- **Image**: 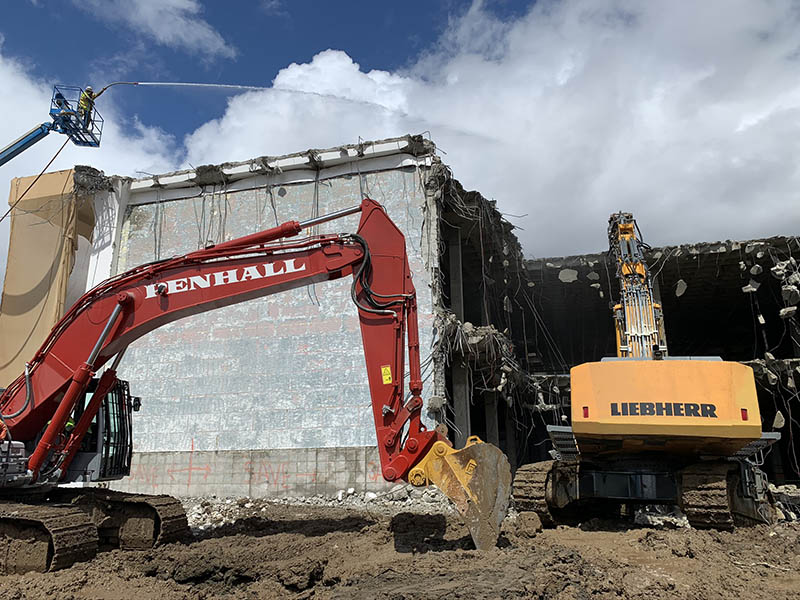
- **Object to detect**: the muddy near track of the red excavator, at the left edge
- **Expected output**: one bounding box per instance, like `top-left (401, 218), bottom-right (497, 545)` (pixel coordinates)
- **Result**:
top-left (0, 502), bottom-right (98, 574)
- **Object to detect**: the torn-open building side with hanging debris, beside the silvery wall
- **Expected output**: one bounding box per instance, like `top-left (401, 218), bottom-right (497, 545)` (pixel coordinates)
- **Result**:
top-left (428, 164), bottom-right (534, 465)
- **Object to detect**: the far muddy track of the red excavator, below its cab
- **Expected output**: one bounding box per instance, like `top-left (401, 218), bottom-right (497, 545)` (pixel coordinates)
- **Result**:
top-left (54, 488), bottom-right (191, 549)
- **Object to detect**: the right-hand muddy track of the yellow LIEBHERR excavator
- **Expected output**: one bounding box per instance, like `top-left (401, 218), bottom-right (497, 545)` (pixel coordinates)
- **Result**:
top-left (680, 462), bottom-right (734, 530)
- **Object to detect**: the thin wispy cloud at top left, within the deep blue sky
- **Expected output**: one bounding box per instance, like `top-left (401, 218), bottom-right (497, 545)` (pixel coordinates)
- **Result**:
top-left (73, 0), bottom-right (236, 58)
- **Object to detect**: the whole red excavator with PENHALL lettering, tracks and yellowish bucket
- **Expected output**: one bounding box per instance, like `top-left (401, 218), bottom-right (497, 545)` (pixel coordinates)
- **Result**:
top-left (0, 199), bottom-right (511, 573)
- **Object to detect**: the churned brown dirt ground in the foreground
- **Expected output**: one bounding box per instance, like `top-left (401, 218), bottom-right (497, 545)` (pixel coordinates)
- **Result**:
top-left (0, 503), bottom-right (800, 600)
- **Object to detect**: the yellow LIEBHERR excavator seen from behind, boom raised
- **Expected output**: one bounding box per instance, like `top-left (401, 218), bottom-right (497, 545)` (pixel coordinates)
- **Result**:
top-left (513, 212), bottom-right (780, 529)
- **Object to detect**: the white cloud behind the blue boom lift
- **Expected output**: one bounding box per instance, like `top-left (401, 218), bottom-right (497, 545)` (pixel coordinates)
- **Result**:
top-left (0, 46), bottom-right (177, 281)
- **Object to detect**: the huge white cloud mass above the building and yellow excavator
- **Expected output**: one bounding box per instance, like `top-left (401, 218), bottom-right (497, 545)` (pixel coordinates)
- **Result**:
top-left (181, 0), bottom-right (800, 256)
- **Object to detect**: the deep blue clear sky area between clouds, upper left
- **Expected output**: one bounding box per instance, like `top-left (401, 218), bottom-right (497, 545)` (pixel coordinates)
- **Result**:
top-left (0, 0), bottom-right (530, 138)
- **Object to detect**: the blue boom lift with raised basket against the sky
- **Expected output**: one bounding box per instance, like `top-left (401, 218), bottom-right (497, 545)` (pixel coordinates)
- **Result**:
top-left (0, 85), bottom-right (103, 166)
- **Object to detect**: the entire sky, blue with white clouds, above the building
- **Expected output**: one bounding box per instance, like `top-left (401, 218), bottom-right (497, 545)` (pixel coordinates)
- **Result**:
top-left (0, 0), bottom-right (800, 290)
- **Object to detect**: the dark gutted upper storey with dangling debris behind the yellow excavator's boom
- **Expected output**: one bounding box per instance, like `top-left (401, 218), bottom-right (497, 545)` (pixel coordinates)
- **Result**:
top-left (526, 237), bottom-right (800, 372)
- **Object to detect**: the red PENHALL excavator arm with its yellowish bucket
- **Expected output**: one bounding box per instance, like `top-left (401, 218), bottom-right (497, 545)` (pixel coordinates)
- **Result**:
top-left (0, 199), bottom-right (511, 548)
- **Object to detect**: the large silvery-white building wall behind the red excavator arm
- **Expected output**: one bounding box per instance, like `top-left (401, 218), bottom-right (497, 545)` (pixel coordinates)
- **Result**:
top-left (108, 157), bottom-right (436, 462)
